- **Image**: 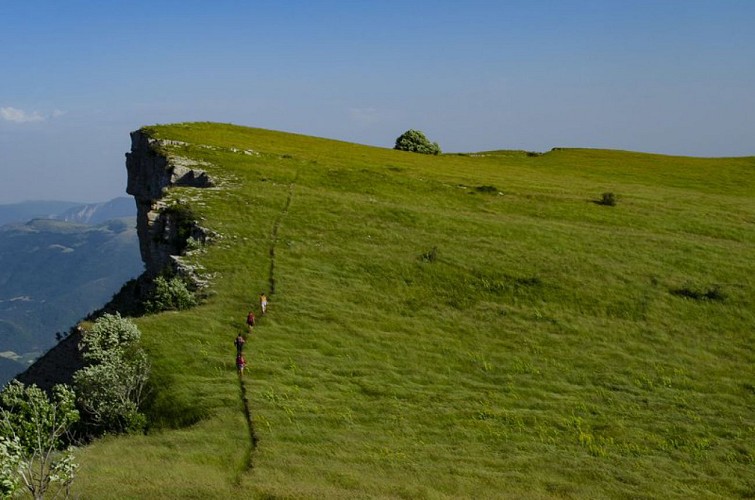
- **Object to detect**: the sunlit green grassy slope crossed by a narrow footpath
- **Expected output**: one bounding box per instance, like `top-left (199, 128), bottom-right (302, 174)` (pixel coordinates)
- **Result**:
top-left (77, 124), bottom-right (755, 498)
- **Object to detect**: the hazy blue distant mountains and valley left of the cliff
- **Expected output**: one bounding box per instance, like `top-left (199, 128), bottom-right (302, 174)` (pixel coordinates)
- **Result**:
top-left (0, 197), bottom-right (143, 384)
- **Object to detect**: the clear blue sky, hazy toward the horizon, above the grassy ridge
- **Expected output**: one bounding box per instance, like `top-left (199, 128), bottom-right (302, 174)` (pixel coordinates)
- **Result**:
top-left (0, 0), bottom-right (755, 204)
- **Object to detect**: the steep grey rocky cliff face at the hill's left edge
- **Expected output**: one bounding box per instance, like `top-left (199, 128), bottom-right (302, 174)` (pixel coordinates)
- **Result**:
top-left (126, 130), bottom-right (213, 283)
